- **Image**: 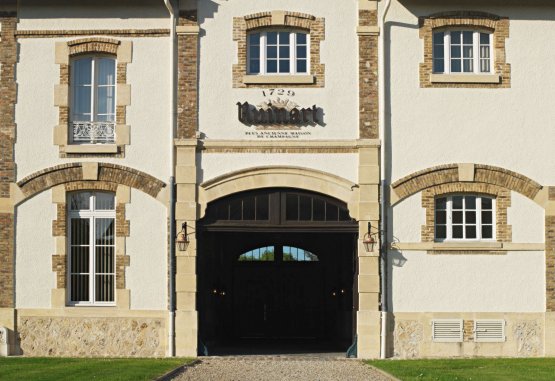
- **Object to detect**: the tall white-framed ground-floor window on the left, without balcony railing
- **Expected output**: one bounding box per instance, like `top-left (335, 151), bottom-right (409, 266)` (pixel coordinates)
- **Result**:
top-left (68, 192), bottom-right (116, 305)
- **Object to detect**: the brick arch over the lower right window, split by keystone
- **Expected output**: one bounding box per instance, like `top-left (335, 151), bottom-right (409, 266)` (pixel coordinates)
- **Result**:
top-left (391, 164), bottom-right (542, 201)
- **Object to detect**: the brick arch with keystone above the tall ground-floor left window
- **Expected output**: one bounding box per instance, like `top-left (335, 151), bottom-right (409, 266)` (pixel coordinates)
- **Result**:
top-left (17, 163), bottom-right (166, 201)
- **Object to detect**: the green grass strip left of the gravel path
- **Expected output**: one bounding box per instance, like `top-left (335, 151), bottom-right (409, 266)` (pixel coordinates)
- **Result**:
top-left (0, 357), bottom-right (194, 381)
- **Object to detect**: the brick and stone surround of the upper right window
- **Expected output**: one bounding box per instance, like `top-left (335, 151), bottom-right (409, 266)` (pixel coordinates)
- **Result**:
top-left (419, 11), bottom-right (511, 88)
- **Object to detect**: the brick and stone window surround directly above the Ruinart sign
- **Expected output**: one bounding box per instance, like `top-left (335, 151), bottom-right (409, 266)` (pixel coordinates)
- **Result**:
top-left (233, 11), bottom-right (325, 88)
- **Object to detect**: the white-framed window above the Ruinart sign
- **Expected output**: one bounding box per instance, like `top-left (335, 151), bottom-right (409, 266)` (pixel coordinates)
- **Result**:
top-left (247, 30), bottom-right (310, 75)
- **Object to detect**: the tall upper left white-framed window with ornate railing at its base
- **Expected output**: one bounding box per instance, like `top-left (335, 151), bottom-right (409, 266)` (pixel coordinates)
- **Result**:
top-left (70, 56), bottom-right (116, 144)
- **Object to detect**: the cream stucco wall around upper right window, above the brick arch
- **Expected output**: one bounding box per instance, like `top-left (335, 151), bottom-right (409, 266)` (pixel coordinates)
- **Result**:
top-left (386, 0), bottom-right (555, 184)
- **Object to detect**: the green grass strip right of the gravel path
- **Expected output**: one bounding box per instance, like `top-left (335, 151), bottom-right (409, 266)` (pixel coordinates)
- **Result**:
top-left (366, 358), bottom-right (555, 381)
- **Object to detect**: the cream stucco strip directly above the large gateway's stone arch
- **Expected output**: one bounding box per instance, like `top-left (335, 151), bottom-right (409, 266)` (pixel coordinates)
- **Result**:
top-left (200, 153), bottom-right (358, 183)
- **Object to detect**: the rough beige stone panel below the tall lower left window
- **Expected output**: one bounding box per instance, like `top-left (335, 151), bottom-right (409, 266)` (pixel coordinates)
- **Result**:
top-left (19, 317), bottom-right (165, 357)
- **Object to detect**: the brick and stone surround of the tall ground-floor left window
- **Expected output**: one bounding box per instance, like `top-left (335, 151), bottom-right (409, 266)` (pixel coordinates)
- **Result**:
top-left (51, 181), bottom-right (131, 310)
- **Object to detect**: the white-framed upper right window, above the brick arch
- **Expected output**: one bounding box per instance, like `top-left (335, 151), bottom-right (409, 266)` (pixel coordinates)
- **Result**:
top-left (433, 30), bottom-right (493, 74)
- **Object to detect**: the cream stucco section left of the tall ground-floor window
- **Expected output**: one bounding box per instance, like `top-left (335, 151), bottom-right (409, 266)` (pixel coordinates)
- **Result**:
top-left (15, 191), bottom-right (56, 308)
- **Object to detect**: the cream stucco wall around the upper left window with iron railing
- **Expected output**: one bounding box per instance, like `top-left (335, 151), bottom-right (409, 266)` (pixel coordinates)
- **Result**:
top-left (15, 36), bottom-right (171, 181)
